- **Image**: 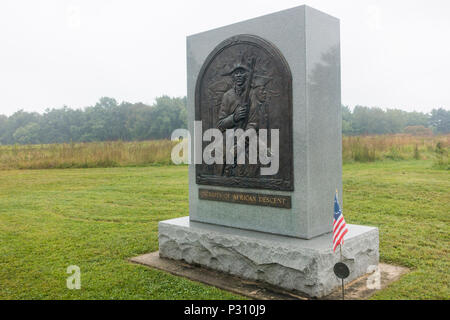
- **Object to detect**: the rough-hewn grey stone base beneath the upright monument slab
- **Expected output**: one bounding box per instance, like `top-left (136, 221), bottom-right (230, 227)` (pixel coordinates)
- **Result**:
top-left (159, 217), bottom-right (379, 298)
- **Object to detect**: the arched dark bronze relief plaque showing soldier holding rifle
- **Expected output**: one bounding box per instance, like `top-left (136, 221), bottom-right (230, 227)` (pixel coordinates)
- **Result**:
top-left (195, 35), bottom-right (294, 191)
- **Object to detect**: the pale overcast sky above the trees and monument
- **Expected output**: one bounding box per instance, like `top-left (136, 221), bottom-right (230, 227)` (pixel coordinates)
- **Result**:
top-left (0, 0), bottom-right (450, 115)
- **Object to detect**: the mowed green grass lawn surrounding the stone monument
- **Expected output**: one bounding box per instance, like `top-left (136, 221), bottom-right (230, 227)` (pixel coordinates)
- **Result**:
top-left (0, 161), bottom-right (450, 299)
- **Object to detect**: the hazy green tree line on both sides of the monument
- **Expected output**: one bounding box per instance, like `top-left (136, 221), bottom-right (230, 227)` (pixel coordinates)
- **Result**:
top-left (0, 96), bottom-right (450, 145)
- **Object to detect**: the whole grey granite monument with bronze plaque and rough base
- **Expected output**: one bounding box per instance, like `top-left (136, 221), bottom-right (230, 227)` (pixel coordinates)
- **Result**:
top-left (159, 6), bottom-right (379, 297)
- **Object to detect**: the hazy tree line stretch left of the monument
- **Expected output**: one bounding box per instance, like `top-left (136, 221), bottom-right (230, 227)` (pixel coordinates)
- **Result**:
top-left (0, 96), bottom-right (187, 144)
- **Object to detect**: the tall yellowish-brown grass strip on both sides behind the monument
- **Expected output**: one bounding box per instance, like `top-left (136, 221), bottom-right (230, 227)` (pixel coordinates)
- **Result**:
top-left (0, 134), bottom-right (450, 170)
